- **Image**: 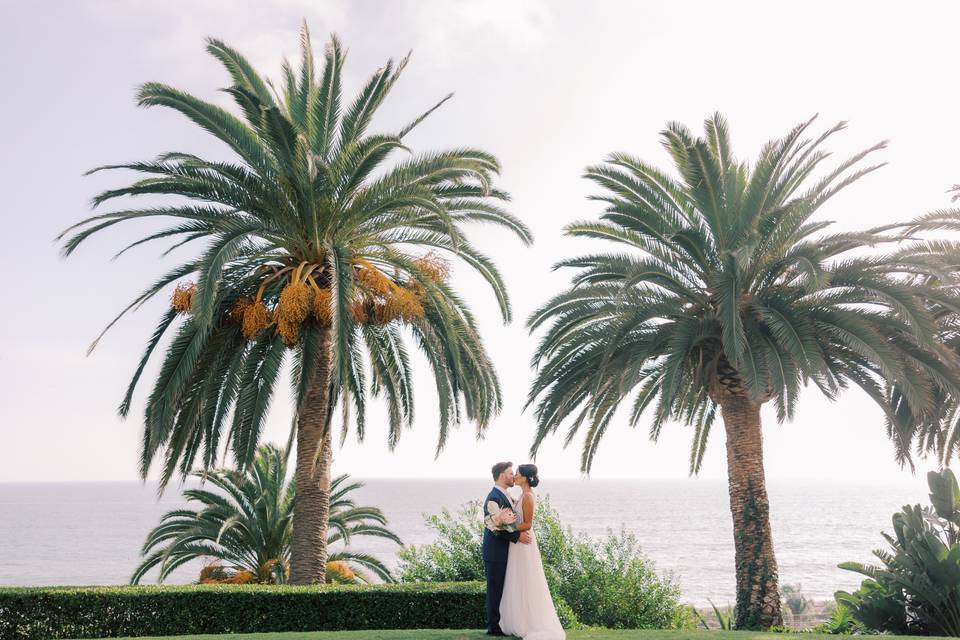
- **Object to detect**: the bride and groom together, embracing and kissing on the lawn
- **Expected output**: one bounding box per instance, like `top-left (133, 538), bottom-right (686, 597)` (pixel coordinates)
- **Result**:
top-left (483, 462), bottom-right (566, 640)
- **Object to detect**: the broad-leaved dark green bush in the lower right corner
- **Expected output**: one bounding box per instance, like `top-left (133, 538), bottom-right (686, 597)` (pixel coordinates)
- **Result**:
top-left (836, 469), bottom-right (960, 636)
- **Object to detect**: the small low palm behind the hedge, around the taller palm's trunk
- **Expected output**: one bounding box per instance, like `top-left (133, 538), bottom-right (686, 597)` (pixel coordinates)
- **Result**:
top-left (130, 445), bottom-right (402, 584)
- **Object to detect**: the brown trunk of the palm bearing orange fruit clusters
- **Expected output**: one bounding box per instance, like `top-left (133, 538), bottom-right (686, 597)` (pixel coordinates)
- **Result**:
top-left (290, 327), bottom-right (333, 584)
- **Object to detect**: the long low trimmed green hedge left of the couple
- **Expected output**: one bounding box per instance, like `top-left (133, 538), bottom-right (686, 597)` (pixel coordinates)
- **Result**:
top-left (0, 582), bottom-right (485, 640)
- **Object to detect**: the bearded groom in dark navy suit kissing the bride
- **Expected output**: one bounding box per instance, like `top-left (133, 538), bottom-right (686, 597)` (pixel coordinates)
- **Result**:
top-left (483, 462), bottom-right (530, 636)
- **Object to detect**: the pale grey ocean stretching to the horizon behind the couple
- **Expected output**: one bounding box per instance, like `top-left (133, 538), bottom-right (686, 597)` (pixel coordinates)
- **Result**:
top-left (0, 478), bottom-right (928, 606)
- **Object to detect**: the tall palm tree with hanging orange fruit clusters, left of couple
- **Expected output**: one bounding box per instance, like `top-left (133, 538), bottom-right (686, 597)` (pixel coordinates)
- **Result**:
top-left (61, 27), bottom-right (532, 584)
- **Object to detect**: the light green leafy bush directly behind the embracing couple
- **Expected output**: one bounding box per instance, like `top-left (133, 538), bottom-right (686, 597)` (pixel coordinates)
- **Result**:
top-left (397, 500), bottom-right (692, 629)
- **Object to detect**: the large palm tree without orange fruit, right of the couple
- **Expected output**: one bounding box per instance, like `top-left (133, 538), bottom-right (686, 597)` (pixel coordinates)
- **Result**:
top-left (528, 115), bottom-right (960, 628)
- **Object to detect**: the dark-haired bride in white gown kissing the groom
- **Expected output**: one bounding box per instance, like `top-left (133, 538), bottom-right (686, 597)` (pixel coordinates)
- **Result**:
top-left (500, 464), bottom-right (566, 640)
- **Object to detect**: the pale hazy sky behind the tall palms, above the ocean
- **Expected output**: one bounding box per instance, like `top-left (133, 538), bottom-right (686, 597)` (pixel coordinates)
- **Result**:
top-left (0, 0), bottom-right (960, 483)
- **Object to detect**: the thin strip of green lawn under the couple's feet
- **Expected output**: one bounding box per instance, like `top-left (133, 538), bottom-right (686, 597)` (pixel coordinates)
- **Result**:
top-left (103, 629), bottom-right (928, 640)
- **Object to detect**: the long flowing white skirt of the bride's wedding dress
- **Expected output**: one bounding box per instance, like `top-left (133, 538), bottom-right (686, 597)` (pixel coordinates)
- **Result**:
top-left (500, 498), bottom-right (566, 640)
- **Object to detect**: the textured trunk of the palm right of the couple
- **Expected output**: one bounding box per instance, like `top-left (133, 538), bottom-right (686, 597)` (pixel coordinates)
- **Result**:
top-left (720, 393), bottom-right (783, 629)
